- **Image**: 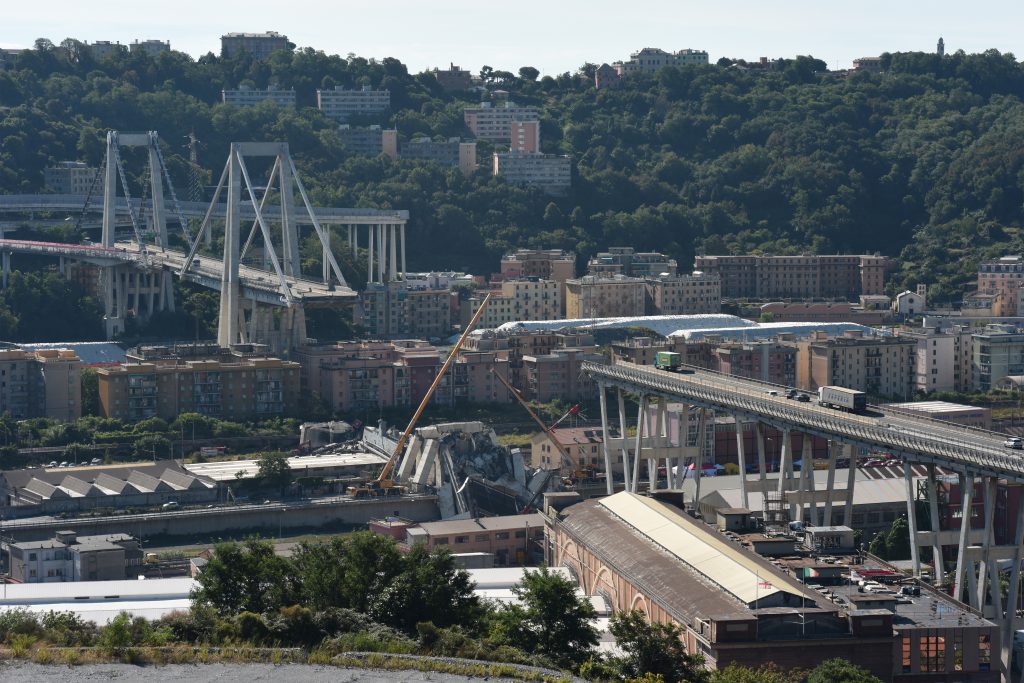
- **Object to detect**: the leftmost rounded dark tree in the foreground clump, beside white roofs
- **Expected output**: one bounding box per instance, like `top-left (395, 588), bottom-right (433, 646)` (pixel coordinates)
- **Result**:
top-left (191, 538), bottom-right (295, 615)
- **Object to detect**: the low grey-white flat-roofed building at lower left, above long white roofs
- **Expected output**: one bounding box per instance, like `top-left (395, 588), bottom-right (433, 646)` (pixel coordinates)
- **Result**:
top-left (7, 531), bottom-right (142, 584)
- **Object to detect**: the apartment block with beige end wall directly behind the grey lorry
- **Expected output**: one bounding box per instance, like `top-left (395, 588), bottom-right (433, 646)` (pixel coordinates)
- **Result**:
top-left (797, 331), bottom-right (918, 399)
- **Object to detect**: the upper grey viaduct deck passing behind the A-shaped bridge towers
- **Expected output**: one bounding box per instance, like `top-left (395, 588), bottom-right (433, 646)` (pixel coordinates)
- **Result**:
top-left (0, 194), bottom-right (409, 225)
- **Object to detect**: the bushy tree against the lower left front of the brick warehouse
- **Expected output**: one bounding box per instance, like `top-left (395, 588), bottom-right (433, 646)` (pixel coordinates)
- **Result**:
top-left (609, 609), bottom-right (708, 683)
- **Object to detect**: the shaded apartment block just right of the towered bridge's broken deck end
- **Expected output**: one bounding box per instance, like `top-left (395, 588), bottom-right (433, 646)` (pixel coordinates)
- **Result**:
top-left (355, 282), bottom-right (453, 339)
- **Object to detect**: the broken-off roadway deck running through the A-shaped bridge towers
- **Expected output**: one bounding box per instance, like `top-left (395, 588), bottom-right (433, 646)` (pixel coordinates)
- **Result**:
top-left (0, 240), bottom-right (355, 307)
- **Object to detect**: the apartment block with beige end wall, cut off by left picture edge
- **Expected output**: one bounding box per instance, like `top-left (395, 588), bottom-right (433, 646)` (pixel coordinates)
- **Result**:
top-left (0, 344), bottom-right (82, 422)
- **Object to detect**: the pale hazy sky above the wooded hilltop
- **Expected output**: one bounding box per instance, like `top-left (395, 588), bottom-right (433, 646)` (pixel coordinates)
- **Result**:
top-left (0, 0), bottom-right (1024, 74)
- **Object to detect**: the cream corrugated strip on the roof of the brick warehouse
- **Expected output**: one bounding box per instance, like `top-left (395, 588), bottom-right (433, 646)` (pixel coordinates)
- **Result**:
top-left (600, 492), bottom-right (804, 604)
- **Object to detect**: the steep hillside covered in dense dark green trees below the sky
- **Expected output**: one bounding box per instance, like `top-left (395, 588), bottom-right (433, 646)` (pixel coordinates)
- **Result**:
top-left (0, 40), bottom-right (1024, 301)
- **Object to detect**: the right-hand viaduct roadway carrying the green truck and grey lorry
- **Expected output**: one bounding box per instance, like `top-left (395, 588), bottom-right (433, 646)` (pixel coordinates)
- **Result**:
top-left (582, 361), bottom-right (1024, 483)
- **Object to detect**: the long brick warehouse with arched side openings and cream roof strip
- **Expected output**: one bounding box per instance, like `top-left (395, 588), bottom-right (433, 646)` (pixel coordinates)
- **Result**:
top-left (546, 493), bottom-right (999, 683)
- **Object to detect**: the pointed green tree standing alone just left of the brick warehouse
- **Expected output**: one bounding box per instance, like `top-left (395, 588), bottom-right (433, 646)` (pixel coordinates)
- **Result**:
top-left (494, 564), bottom-right (598, 667)
